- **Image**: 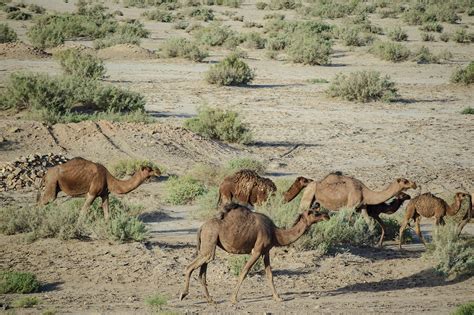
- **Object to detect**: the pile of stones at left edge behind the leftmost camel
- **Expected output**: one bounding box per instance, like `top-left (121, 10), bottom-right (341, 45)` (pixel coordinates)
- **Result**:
top-left (0, 153), bottom-right (68, 191)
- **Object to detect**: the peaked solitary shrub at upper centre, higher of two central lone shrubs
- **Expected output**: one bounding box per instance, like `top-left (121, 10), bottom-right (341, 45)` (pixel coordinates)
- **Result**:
top-left (206, 54), bottom-right (255, 85)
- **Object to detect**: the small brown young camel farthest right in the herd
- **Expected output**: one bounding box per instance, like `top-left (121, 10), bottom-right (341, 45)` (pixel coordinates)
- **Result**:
top-left (398, 192), bottom-right (471, 249)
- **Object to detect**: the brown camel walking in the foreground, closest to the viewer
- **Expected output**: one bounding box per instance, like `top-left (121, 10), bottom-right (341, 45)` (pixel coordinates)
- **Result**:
top-left (180, 203), bottom-right (329, 303)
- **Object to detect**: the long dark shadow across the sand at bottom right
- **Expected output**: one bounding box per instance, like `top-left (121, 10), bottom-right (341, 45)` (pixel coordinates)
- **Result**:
top-left (326, 268), bottom-right (470, 296)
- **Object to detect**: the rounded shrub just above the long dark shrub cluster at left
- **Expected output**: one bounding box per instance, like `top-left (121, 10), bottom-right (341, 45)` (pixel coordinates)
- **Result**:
top-left (55, 48), bottom-right (105, 79)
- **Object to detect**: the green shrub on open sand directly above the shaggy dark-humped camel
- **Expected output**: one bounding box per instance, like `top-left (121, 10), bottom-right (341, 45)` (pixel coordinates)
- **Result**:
top-left (184, 106), bottom-right (251, 144)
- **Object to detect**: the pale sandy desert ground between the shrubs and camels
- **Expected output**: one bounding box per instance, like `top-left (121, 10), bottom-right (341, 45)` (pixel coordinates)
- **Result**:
top-left (0, 0), bottom-right (474, 314)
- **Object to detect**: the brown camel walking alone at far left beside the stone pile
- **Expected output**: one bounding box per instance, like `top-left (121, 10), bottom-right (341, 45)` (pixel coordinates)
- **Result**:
top-left (37, 157), bottom-right (161, 220)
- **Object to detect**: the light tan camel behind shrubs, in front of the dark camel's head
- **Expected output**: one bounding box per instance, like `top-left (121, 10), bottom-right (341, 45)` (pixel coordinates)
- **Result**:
top-left (300, 173), bottom-right (416, 211)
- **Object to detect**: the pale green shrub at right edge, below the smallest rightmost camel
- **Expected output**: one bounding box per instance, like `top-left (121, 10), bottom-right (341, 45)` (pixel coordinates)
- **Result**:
top-left (425, 222), bottom-right (474, 277)
